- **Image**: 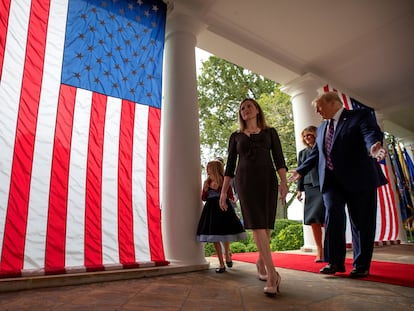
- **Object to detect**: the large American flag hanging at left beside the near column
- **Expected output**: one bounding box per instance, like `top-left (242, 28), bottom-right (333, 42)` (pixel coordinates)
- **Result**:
top-left (0, 0), bottom-right (168, 277)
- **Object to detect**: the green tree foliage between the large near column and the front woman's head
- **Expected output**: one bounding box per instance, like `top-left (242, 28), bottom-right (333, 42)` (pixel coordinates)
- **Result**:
top-left (198, 56), bottom-right (276, 160)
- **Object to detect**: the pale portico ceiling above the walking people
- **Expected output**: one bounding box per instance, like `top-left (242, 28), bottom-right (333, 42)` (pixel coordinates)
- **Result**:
top-left (170, 0), bottom-right (414, 144)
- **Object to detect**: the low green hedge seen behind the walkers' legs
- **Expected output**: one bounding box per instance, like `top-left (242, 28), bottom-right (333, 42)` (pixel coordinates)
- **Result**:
top-left (204, 219), bottom-right (303, 257)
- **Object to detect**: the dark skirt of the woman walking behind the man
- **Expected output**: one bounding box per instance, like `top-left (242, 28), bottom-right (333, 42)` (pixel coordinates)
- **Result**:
top-left (303, 184), bottom-right (325, 225)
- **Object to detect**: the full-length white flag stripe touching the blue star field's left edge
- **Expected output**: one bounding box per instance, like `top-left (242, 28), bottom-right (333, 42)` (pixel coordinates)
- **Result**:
top-left (23, 1), bottom-right (67, 269)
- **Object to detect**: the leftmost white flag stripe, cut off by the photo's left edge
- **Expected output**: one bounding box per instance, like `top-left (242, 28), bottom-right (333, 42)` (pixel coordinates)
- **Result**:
top-left (0, 0), bottom-right (30, 260)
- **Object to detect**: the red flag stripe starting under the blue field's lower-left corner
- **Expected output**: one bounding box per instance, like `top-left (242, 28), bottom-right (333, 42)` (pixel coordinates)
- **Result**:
top-left (45, 84), bottom-right (76, 271)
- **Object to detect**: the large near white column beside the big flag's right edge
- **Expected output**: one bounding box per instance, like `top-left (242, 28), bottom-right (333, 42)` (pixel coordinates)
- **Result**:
top-left (161, 14), bottom-right (207, 265)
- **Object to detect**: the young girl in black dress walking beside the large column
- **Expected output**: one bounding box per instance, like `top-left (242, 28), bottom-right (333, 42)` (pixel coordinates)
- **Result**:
top-left (197, 160), bottom-right (247, 273)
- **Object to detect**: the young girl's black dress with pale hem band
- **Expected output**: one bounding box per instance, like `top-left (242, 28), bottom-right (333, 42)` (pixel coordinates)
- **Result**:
top-left (197, 187), bottom-right (247, 242)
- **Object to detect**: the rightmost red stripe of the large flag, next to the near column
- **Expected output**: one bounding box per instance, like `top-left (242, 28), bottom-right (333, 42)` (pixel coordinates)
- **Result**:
top-left (146, 107), bottom-right (164, 261)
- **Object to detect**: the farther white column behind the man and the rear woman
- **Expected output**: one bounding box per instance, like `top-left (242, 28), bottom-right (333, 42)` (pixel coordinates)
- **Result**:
top-left (282, 73), bottom-right (326, 252)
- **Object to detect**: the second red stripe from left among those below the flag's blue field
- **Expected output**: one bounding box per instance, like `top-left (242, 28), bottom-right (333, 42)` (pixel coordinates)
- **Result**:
top-left (85, 93), bottom-right (106, 269)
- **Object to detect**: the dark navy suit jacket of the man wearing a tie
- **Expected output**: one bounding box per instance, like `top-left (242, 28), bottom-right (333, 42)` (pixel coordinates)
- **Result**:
top-left (296, 109), bottom-right (387, 192)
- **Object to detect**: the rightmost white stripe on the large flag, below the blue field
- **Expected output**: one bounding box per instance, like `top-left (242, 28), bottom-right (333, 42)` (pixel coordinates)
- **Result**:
top-left (132, 104), bottom-right (151, 262)
